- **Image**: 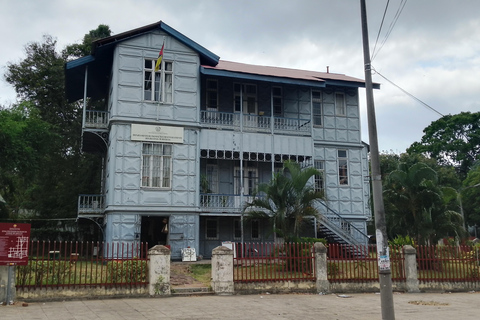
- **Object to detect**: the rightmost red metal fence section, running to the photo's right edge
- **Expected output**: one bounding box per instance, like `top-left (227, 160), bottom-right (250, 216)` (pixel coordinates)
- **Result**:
top-left (417, 246), bottom-right (480, 283)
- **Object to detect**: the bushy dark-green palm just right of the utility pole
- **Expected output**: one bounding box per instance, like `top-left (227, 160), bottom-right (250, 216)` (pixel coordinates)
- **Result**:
top-left (384, 162), bottom-right (464, 244)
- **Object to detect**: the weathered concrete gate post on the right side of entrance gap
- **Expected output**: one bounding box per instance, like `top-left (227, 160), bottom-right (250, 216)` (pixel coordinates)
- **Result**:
top-left (212, 246), bottom-right (234, 295)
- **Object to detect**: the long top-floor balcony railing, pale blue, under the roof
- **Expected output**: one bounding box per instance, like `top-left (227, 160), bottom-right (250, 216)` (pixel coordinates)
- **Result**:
top-left (201, 110), bottom-right (310, 135)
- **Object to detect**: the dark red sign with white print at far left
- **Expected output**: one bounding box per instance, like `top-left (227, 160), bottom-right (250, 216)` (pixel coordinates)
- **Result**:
top-left (0, 223), bottom-right (30, 265)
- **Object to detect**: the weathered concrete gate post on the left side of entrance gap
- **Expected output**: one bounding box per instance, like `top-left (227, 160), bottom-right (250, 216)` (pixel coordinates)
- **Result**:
top-left (148, 245), bottom-right (171, 296)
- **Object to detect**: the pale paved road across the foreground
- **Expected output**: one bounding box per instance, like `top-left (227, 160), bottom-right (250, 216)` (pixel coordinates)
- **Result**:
top-left (0, 292), bottom-right (480, 320)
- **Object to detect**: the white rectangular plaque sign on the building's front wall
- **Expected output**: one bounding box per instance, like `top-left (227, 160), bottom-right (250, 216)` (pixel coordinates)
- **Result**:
top-left (130, 124), bottom-right (183, 143)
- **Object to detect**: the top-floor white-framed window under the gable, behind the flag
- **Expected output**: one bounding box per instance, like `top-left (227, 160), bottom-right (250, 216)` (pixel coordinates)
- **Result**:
top-left (143, 59), bottom-right (173, 103)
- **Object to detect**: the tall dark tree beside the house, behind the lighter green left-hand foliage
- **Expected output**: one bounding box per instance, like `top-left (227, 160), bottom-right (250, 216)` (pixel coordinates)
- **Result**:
top-left (0, 25), bottom-right (110, 224)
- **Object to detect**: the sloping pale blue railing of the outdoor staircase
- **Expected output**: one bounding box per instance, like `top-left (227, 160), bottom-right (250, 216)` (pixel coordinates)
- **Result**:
top-left (317, 201), bottom-right (368, 245)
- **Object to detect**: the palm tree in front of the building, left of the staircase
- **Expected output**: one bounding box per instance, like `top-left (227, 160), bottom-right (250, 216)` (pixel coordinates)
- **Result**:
top-left (245, 161), bottom-right (324, 239)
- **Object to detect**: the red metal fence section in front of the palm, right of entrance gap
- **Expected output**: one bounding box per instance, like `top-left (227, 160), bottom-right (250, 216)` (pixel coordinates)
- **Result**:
top-left (233, 243), bottom-right (316, 282)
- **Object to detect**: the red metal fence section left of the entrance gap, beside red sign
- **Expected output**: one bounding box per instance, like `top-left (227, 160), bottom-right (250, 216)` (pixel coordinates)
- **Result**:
top-left (16, 241), bottom-right (148, 289)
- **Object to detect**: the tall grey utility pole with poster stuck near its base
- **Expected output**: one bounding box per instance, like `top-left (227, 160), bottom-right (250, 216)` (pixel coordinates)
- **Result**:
top-left (360, 0), bottom-right (395, 320)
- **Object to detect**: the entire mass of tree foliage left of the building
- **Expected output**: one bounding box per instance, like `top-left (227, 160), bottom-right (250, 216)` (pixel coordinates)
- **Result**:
top-left (0, 25), bottom-right (111, 222)
